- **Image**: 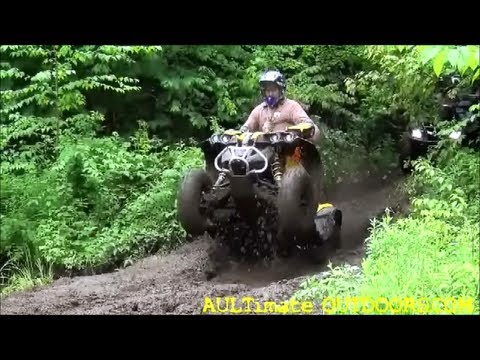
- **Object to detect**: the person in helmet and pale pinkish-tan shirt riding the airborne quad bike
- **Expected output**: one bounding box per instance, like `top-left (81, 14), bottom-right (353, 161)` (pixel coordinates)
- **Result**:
top-left (240, 70), bottom-right (320, 144)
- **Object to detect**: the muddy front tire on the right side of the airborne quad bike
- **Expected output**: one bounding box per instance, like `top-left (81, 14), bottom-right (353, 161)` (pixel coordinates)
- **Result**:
top-left (278, 166), bottom-right (319, 250)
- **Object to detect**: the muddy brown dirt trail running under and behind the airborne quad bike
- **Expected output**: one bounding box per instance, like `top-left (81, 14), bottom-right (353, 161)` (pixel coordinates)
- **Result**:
top-left (0, 167), bottom-right (402, 314)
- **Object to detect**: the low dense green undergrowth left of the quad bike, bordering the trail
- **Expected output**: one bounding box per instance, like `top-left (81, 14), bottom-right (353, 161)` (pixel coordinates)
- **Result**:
top-left (0, 125), bottom-right (202, 290)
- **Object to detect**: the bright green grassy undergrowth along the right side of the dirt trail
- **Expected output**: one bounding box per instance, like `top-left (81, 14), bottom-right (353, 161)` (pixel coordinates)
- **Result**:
top-left (294, 147), bottom-right (480, 314)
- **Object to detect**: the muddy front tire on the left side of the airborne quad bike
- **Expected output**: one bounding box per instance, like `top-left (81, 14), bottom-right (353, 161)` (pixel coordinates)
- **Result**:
top-left (177, 169), bottom-right (213, 236)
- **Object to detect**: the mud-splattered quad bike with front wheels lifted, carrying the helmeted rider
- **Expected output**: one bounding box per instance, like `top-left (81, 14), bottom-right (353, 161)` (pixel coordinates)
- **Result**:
top-left (177, 124), bottom-right (341, 268)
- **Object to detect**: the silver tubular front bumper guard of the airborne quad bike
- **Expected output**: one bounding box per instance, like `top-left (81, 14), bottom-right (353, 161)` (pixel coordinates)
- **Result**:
top-left (214, 146), bottom-right (268, 176)
